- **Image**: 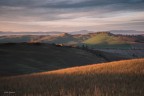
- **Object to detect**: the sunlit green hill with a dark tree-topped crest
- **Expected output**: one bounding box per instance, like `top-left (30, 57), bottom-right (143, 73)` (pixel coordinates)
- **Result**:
top-left (84, 32), bottom-right (135, 45)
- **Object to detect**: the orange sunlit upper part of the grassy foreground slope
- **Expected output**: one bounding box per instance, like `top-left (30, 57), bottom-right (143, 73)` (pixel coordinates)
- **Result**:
top-left (46, 59), bottom-right (144, 75)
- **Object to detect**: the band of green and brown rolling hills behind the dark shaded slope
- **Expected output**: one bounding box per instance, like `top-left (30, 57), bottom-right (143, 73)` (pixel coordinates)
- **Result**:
top-left (0, 32), bottom-right (144, 49)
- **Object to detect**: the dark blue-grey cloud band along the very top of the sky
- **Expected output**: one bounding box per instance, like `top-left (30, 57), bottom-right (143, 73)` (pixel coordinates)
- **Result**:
top-left (0, 0), bottom-right (144, 9)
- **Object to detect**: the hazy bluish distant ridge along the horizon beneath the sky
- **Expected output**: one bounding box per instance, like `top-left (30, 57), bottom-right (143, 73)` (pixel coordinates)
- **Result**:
top-left (0, 30), bottom-right (144, 36)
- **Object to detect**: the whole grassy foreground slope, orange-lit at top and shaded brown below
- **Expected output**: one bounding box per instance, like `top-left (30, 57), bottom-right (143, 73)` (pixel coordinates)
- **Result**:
top-left (0, 59), bottom-right (144, 96)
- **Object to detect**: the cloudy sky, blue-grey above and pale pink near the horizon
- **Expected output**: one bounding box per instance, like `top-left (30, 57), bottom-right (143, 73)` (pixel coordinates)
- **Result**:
top-left (0, 0), bottom-right (144, 32)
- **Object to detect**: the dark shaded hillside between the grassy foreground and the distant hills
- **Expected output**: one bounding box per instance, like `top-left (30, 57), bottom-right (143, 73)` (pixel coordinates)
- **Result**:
top-left (0, 43), bottom-right (127, 76)
